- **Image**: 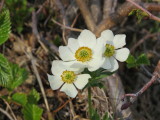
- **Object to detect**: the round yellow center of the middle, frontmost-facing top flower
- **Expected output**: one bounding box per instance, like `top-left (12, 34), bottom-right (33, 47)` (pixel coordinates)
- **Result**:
top-left (75, 47), bottom-right (92, 62)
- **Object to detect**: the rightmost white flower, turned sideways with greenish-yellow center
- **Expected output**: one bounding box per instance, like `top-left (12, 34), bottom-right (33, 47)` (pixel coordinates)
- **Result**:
top-left (97, 30), bottom-right (130, 72)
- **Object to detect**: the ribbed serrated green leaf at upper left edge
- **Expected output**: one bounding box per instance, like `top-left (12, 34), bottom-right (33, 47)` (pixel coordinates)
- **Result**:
top-left (0, 10), bottom-right (11, 45)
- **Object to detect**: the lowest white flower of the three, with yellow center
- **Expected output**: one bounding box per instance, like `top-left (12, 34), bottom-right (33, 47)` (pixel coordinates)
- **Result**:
top-left (48, 60), bottom-right (91, 98)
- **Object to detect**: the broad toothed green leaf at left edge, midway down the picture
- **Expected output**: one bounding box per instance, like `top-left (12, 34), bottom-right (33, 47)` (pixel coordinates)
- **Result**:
top-left (0, 54), bottom-right (28, 91)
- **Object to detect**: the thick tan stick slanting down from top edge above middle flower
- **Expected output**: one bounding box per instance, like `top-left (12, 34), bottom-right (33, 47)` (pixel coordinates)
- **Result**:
top-left (76, 0), bottom-right (96, 31)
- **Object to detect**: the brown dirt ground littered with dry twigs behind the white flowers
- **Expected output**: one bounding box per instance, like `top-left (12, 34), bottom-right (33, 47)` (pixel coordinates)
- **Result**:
top-left (0, 0), bottom-right (160, 120)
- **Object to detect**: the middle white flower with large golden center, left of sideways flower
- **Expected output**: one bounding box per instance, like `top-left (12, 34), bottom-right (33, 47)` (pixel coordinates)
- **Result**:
top-left (59, 30), bottom-right (102, 71)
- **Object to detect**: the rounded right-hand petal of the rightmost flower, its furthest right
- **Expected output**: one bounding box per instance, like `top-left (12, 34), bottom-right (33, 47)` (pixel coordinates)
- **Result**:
top-left (114, 48), bottom-right (130, 62)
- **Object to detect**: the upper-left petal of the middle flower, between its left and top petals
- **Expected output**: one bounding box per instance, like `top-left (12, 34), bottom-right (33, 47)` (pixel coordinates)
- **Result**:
top-left (68, 38), bottom-right (79, 53)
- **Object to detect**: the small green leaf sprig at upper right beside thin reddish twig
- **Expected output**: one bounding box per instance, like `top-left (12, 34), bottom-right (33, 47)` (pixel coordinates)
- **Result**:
top-left (129, 9), bottom-right (148, 23)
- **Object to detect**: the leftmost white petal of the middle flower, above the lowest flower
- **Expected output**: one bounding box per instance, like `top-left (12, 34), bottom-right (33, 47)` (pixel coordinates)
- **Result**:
top-left (59, 46), bottom-right (75, 61)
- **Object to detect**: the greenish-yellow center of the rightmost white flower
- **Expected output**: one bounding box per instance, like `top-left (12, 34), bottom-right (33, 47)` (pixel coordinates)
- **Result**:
top-left (104, 44), bottom-right (115, 57)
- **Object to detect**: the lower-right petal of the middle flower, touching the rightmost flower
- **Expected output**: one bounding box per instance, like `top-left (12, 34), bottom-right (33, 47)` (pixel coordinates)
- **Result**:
top-left (88, 56), bottom-right (105, 71)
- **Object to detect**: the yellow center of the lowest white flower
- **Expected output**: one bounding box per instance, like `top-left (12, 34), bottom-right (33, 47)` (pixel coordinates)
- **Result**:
top-left (61, 70), bottom-right (76, 84)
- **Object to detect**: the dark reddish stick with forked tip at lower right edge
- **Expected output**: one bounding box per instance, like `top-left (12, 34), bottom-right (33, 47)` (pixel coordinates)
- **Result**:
top-left (121, 60), bottom-right (160, 110)
